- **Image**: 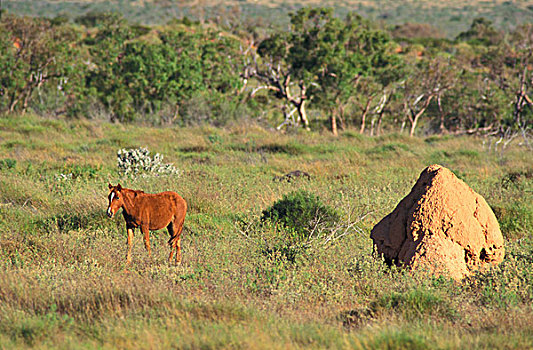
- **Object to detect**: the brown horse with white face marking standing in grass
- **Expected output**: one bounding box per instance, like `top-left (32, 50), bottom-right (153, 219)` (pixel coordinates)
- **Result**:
top-left (107, 184), bottom-right (187, 264)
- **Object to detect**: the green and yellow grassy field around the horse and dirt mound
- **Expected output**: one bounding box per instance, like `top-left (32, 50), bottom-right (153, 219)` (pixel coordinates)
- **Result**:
top-left (0, 116), bottom-right (533, 349)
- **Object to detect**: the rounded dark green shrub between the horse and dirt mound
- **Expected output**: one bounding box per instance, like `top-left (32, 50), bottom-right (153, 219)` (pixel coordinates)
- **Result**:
top-left (261, 190), bottom-right (339, 242)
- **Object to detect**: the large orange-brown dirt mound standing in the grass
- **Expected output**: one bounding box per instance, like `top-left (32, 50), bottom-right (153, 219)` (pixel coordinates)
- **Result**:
top-left (370, 165), bottom-right (504, 280)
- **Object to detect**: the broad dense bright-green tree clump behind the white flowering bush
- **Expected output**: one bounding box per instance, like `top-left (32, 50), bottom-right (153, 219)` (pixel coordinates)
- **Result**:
top-left (82, 17), bottom-right (241, 122)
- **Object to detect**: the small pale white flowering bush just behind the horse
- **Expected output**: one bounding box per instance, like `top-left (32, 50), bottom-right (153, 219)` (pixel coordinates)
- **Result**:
top-left (117, 147), bottom-right (180, 176)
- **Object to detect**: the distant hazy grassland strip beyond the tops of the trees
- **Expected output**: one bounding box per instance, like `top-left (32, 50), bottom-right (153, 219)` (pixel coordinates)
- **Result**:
top-left (3, 0), bottom-right (533, 38)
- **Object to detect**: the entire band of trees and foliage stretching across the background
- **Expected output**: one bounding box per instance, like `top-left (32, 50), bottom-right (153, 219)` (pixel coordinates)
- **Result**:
top-left (0, 5), bottom-right (533, 139)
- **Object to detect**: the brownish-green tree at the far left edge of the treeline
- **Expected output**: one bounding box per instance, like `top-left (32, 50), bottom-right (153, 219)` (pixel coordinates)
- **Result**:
top-left (0, 16), bottom-right (79, 113)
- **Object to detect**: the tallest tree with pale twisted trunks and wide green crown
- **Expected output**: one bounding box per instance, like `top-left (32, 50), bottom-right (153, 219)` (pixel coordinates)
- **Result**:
top-left (252, 8), bottom-right (399, 134)
